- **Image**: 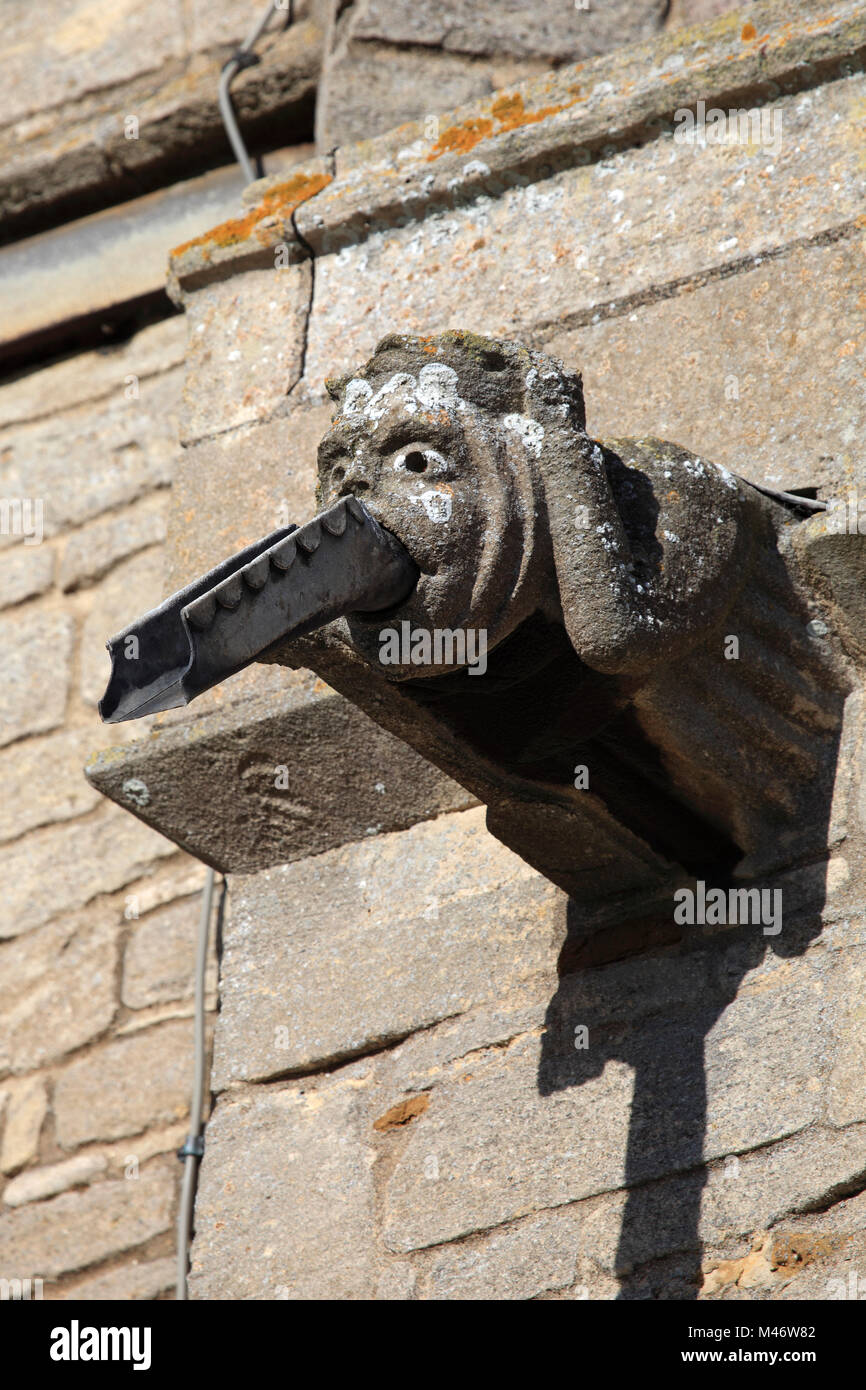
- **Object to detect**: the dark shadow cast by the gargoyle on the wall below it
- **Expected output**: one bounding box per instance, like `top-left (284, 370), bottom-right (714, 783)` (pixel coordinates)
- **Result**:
top-left (538, 850), bottom-right (841, 1300)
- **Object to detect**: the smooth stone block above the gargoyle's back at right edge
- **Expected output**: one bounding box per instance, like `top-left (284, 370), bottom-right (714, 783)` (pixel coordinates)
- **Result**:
top-left (545, 236), bottom-right (866, 499)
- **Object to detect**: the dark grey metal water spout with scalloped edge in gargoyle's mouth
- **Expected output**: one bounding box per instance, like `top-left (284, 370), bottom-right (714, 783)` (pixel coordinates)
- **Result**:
top-left (99, 496), bottom-right (418, 724)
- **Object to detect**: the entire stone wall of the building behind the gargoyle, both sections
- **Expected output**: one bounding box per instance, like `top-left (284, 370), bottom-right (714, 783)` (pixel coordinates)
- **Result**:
top-left (0, 0), bottom-right (866, 1298)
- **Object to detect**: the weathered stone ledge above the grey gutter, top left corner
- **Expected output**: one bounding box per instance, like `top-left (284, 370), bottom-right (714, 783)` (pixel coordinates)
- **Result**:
top-left (0, 0), bottom-right (322, 236)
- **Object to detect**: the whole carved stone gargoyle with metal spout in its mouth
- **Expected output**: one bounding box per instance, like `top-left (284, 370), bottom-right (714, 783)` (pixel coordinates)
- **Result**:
top-left (100, 332), bottom-right (856, 904)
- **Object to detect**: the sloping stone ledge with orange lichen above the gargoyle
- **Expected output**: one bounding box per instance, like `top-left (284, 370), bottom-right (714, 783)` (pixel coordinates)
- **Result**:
top-left (171, 0), bottom-right (866, 297)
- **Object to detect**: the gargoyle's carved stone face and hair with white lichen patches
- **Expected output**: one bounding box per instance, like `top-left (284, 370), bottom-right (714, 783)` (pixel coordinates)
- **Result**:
top-left (312, 332), bottom-right (584, 678)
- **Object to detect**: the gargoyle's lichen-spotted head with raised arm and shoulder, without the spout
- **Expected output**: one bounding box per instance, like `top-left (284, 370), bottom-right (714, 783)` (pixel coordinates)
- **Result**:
top-left (318, 332), bottom-right (749, 678)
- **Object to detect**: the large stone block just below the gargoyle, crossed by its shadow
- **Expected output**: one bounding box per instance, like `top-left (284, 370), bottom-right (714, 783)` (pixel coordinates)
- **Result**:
top-left (386, 941), bottom-right (859, 1251)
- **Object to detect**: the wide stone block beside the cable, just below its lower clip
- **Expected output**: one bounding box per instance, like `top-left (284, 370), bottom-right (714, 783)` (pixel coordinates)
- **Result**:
top-left (0, 1163), bottom-right (177, 1279)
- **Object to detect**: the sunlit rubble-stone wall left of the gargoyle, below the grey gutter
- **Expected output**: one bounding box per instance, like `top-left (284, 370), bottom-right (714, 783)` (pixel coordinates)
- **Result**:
top-left (0, 318), bottom-right (215, 1298)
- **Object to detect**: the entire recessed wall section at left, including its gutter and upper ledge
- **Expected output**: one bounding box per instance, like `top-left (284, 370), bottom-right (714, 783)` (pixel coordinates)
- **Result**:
top-left (0, 0), bottom-right (322, 1300)
